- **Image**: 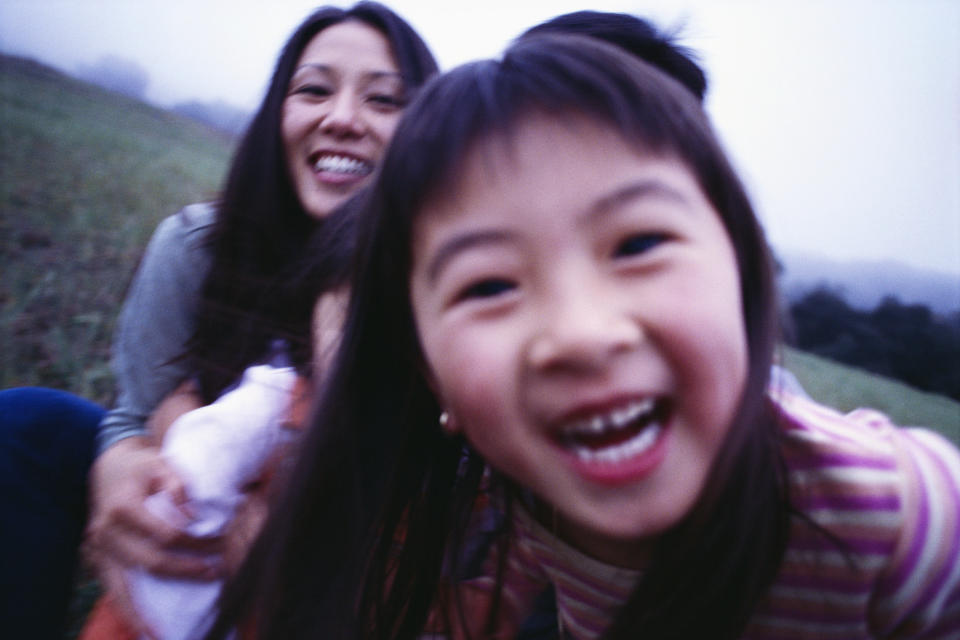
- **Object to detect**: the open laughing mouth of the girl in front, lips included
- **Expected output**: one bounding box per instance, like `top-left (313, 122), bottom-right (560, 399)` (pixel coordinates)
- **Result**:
top-left (558, 398), bottom-right (670, 484)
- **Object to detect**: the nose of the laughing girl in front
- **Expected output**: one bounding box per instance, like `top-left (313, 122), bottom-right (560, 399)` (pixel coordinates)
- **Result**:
top-left (528, 291), bottom-right (644, 371)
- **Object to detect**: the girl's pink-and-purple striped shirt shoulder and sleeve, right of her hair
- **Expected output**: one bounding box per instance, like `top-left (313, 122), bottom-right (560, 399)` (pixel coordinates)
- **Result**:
top-left (771, 393), bottom-right (960, 637)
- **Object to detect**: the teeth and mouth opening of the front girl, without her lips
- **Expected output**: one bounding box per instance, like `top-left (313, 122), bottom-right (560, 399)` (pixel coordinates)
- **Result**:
top-left (562, 398), bottom-right (661, 463)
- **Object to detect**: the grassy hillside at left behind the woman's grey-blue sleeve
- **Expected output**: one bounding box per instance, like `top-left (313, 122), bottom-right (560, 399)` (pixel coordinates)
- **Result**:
top-left (0, 56), bottom-right (233, 403)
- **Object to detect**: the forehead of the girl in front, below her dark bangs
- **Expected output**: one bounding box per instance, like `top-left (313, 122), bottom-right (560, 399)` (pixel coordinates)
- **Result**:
top-left (414, 114), bottom-right (710, 245)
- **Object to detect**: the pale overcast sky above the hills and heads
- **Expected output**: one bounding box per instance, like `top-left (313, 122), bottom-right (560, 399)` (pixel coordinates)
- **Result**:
top-left (0, 0), bottom-right (960, 277)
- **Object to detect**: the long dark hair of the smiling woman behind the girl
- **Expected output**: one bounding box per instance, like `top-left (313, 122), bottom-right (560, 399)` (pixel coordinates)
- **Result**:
top-left (188, 2), bottom-right (437, 402)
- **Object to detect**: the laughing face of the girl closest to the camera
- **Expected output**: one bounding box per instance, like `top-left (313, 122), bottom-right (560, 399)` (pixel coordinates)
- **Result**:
top-left (410, 116), bottom-right (748, 566)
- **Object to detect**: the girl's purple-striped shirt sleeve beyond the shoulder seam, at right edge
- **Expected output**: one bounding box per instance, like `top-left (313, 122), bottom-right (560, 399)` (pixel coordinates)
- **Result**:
top-left (872, 420), bottom-right (960, 638)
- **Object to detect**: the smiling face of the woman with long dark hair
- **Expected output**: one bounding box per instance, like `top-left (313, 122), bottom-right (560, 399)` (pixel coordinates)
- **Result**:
top-left (280, 21), bottom-right (406, 218)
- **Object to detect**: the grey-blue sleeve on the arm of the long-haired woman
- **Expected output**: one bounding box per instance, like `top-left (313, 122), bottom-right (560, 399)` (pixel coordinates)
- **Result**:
top-left (97, 204), bottom-right (213, 453)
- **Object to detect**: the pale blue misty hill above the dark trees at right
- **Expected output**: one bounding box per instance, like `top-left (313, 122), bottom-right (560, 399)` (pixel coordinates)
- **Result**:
top-left (777, 252), bottom-right (960, 315)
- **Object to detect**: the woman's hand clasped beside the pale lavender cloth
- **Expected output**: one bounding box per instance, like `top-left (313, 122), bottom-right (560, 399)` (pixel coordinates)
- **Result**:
top-left (85, 437), bottom-right (222, 634)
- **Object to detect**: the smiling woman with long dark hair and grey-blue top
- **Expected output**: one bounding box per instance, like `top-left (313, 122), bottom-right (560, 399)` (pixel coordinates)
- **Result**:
top-left (3, 2), bottom-right (437, 637)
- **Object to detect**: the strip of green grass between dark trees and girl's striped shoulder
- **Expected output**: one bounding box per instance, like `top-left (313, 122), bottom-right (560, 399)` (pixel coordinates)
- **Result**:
top-left (782, 348), bottom-right (960, 445)
